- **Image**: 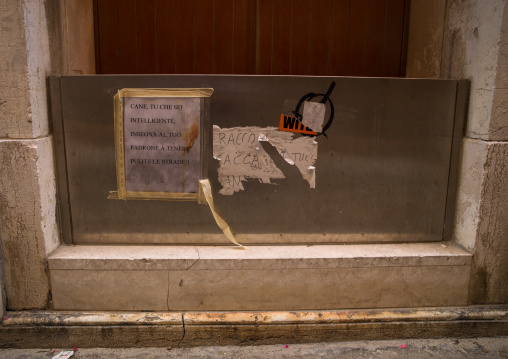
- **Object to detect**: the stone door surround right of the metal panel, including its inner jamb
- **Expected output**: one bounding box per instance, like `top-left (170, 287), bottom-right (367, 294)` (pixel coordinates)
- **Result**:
top-left (408, 0), bottom-right (508, 304)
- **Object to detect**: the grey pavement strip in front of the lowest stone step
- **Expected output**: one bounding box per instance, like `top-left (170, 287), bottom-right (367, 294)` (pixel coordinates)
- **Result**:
top-left (0, 337), bottom-right (508, 359)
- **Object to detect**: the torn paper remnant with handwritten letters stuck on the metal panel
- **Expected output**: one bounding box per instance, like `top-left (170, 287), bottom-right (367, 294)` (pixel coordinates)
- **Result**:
top-left (213, 126), bottom-right (317, 195)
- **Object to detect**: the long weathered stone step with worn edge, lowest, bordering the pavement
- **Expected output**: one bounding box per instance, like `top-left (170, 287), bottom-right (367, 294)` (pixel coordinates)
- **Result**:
top-left (0, 305), bottom-right (508, 348)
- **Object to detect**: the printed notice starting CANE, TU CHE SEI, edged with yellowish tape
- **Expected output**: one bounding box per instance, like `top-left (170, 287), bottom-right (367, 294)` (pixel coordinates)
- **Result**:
top-left (109, 88), bottom-right (213, 201)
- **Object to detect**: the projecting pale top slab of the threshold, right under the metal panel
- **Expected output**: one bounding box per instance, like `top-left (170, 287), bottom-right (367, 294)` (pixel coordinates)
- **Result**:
top-left (48, 242), bottom-right (472, 270)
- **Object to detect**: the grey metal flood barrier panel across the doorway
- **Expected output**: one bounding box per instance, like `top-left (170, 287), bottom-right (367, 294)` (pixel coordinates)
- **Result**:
top-left (50, 75), bottom-right (469, 245)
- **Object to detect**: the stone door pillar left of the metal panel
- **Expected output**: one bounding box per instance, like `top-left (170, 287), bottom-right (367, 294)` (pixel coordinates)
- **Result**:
top-left (0, 0), bottom-right (59, 309)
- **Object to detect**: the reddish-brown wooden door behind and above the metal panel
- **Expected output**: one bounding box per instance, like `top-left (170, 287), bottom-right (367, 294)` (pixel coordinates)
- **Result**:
top-left (94, 0), bottom-right (410, 77)
